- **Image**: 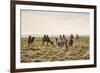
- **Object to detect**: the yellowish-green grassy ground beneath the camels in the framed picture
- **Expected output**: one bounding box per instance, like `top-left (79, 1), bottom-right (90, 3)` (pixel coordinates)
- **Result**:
top-left (21, 36), bottom-right (89, 63)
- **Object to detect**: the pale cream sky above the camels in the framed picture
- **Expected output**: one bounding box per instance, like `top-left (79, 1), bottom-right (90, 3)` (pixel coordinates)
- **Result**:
top-left (21, 10), bottom-right (90, 35)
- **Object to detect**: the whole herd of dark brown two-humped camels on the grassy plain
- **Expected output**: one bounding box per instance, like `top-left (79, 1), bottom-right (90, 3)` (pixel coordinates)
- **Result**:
top-left (28, 34), bottom-right (79, 48)
